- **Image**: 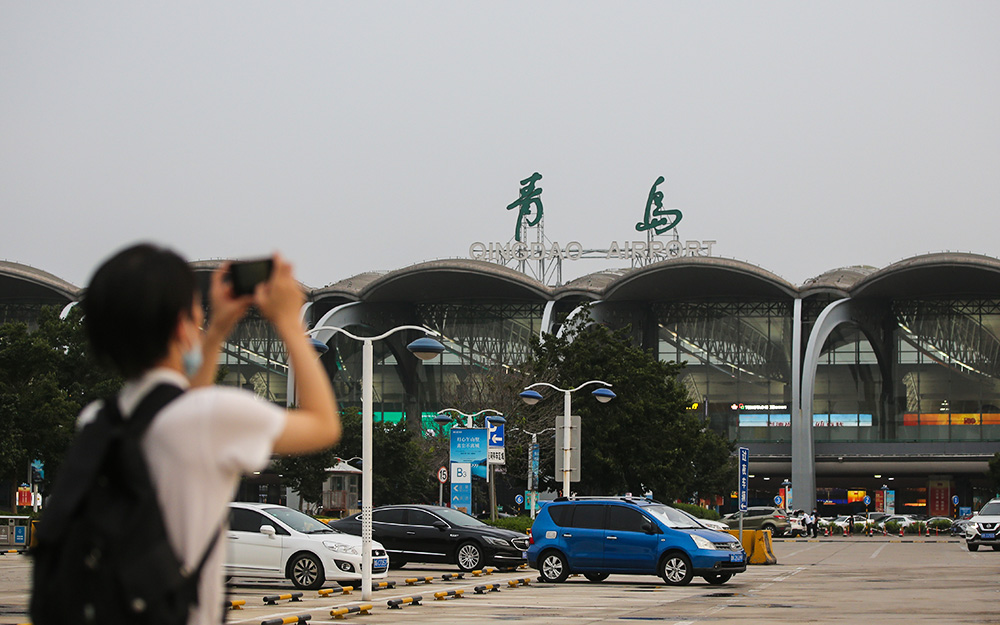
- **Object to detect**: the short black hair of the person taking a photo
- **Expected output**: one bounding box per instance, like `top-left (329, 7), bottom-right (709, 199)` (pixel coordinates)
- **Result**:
top-left (82, 243), bottom-right (196, 379)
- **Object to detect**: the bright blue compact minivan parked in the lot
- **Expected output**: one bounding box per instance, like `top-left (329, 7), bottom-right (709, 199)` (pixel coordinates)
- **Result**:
top-left (527, 497), bottom-right (747, 586)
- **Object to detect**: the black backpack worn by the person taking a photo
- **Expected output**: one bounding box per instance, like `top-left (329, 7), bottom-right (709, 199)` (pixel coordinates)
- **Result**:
top-left (31, 384), bottom-right (218, 625)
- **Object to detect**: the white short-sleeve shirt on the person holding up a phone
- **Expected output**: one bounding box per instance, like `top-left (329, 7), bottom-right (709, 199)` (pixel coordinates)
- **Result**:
top-left (78, 369), bottom-right (286, 625)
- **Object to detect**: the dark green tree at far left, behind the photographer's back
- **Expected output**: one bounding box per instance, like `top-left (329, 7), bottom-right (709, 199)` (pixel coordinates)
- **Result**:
top-left (0, 307), bottom-right (121, 504)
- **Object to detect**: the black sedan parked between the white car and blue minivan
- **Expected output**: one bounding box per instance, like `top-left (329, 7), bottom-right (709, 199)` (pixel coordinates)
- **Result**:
top-left (329, 504), bottom-right (528, 571)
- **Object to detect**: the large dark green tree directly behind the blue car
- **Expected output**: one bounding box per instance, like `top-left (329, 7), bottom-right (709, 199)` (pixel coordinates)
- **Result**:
top-left (508, 316), bottom-right (735, 500)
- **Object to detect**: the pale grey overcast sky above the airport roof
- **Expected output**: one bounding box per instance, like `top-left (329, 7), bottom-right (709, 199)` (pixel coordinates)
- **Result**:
top-left (0, 0), bottom-right (1000, 286)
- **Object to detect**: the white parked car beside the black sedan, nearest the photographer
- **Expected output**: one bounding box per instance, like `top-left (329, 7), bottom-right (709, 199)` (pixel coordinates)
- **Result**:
top-left (225, 502), bottom-right (389, 590)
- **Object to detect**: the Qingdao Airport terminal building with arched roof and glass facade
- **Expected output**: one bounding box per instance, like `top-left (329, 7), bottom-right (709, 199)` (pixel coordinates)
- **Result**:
top-left (7, 253), bottom-right (1000, 515)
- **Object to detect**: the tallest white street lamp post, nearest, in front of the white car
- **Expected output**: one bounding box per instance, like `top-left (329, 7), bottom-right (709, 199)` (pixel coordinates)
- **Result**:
top-left (306, 326), bottom-right (444, 601)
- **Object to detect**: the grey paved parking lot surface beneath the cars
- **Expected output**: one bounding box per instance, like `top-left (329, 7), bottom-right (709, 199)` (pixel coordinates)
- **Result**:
top-left (0, 538), bottom-right (1000, 625)
